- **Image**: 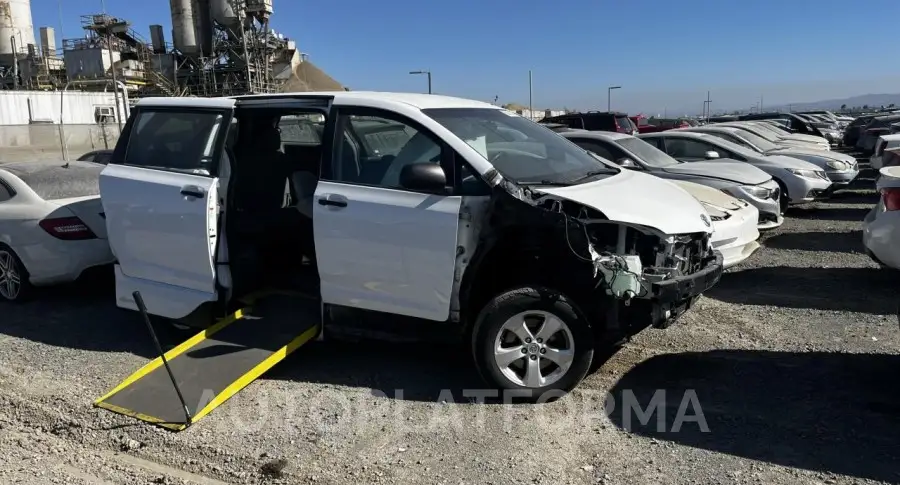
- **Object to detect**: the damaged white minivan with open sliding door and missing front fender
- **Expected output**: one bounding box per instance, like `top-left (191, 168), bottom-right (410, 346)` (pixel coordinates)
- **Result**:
top-left (100, 92), bottom-right (722, 396)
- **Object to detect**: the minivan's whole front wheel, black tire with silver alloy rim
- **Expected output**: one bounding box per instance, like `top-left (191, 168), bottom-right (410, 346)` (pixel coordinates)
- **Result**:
top-left (472, 287), bottom-right (595, 402)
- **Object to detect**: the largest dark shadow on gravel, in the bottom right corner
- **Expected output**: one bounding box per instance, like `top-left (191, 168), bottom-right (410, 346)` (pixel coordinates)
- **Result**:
top-left (610, 350), bottom-right (900, 483)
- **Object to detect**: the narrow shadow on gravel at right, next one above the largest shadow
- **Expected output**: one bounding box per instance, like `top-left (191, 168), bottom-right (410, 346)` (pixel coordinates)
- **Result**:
top-left (705, 266), bottom-right (900, 315)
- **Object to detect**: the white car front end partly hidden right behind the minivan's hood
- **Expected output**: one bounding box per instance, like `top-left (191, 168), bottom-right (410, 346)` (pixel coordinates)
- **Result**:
top-left (672, 180), bottom-right (759, 268)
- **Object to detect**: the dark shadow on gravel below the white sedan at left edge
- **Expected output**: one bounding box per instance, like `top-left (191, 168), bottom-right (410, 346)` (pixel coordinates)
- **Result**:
top-left (0, 274), bottom-right (186, 357)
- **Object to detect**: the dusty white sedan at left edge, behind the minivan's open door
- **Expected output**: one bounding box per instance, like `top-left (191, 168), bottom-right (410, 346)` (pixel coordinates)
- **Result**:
top-left (0, 162), bottom-right (115, 301)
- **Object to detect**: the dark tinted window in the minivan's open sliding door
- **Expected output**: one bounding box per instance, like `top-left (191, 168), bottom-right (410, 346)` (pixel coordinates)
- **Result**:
top-left (123, 110), bottom-right (225, 175)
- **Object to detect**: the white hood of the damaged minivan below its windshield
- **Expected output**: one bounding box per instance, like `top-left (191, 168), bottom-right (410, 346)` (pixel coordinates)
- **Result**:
top-left (535, 170), bottom-right (712, 235)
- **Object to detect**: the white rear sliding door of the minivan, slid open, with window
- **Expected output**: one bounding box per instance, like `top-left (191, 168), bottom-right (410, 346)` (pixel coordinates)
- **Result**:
top-left (100, 99), bottom-right (234, 319)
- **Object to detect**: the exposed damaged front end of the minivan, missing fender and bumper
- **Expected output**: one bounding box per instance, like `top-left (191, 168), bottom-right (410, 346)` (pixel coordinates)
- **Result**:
top-left (454, 179), bottom-right (723, 341)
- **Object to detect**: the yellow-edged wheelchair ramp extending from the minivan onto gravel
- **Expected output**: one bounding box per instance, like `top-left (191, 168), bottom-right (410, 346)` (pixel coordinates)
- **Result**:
top-left (94, 294), bottom-right (321, 431)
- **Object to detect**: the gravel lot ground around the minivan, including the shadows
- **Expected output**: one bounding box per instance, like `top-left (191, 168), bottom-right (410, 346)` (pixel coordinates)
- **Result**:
top-left (0, 149), bottom-right (900, 485)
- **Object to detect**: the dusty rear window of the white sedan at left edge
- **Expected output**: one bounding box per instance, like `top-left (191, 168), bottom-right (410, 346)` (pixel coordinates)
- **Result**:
top-left (0, 161), bottom-right (103, 200)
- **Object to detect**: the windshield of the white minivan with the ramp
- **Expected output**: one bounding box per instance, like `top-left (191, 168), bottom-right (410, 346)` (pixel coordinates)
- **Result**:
top-left (422, 108), bottom-right (619, 184)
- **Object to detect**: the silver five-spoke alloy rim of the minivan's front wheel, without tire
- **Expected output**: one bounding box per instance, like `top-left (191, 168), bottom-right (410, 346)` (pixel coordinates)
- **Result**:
top-left (494, 310), bottom-right (575, 389)
